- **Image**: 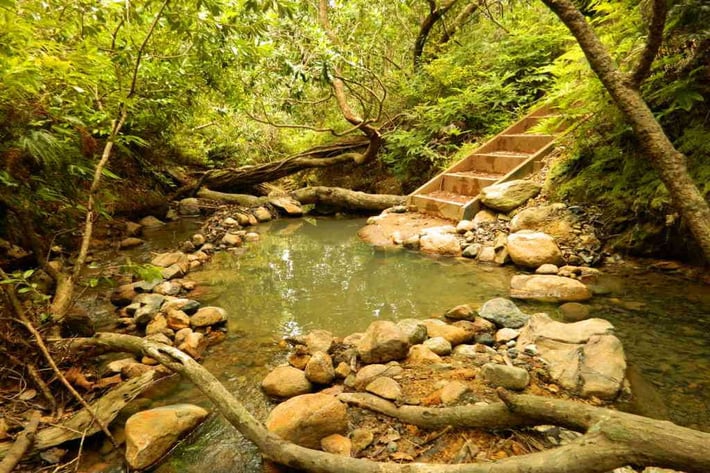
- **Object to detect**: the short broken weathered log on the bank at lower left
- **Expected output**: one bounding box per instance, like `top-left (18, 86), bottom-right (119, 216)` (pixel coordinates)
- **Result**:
top-left (0, 370), bottom-right (158, 458)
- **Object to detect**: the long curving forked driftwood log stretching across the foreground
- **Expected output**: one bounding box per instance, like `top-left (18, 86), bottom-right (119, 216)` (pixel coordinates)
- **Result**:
top-left (71, 333), bottom-right (710, 473)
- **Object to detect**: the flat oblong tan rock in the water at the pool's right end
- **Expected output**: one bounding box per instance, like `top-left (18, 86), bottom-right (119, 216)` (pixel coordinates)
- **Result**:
top-left (510, 274), bottom-right (592, 302)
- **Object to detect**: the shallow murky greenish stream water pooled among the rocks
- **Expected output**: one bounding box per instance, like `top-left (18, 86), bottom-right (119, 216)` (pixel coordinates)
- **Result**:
top-left (105, 218), bottom-right (710, 473)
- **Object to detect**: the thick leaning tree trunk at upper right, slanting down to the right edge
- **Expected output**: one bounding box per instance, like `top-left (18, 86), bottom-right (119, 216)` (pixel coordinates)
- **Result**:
top-left (542, 0), bottom-right (710, 262)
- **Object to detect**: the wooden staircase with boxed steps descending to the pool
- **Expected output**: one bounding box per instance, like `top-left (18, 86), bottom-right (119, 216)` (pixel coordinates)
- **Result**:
top-left (407, 106), bottom-right (566, 220)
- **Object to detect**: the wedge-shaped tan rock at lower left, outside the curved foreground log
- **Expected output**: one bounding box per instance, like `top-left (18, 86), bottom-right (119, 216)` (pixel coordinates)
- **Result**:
top-left (125, 404), bottom-right (209, 470)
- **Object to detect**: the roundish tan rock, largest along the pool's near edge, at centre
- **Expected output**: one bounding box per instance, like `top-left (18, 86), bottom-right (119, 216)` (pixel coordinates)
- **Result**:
top-left (356, 320), bottom-right (409, 363)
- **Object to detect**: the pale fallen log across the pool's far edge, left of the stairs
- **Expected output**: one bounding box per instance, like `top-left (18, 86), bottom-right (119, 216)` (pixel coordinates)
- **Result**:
top-left (197, 186), bottom-right (406, 211)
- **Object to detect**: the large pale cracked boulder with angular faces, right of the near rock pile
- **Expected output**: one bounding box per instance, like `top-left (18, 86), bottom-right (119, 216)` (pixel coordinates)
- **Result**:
top-left (518, 314), bottom-right (626, 399)
